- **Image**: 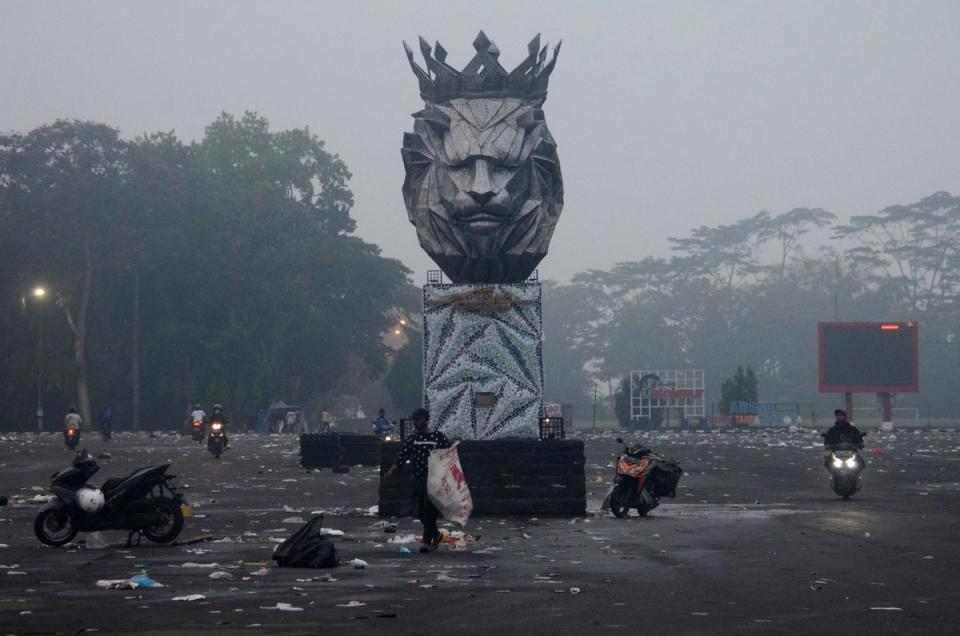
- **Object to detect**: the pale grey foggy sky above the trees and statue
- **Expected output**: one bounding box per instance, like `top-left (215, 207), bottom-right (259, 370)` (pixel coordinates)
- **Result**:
top-left (0, 0), bottom-right (960, 284)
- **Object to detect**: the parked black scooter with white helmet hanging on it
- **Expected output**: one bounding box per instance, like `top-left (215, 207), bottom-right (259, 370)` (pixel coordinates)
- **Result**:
top-left (33, 449), bottom-right (185, 546)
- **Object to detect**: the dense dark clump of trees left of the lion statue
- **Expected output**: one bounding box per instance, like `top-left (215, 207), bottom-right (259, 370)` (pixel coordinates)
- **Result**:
top-left (0, 113), bottom-right (417, 428)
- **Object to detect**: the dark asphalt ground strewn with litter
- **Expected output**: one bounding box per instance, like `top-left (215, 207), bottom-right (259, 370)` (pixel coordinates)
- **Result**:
top-left (0, 430), bottom-right (960, 634)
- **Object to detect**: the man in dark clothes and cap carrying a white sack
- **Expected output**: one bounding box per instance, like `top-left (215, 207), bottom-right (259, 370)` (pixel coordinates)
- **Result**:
top-left (383, 408), bottom-right (450, 552)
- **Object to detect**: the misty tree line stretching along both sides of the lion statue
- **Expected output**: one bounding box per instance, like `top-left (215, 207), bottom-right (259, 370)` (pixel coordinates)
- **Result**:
top-left (0, 113), bottom-right (960, 429)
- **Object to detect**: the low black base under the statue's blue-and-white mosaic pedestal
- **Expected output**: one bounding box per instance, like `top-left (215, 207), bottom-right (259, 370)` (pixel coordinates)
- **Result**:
top-left (380, 439), bottom-right (586, 516)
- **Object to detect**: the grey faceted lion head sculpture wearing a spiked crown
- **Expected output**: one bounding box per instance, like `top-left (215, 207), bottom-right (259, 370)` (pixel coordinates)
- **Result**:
top-left (402, 32), bottom-right (563, 283)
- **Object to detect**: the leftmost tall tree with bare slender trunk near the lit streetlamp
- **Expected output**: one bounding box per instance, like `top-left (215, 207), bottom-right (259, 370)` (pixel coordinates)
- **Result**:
top-left (0, 120), bottom-right (125, 425)
